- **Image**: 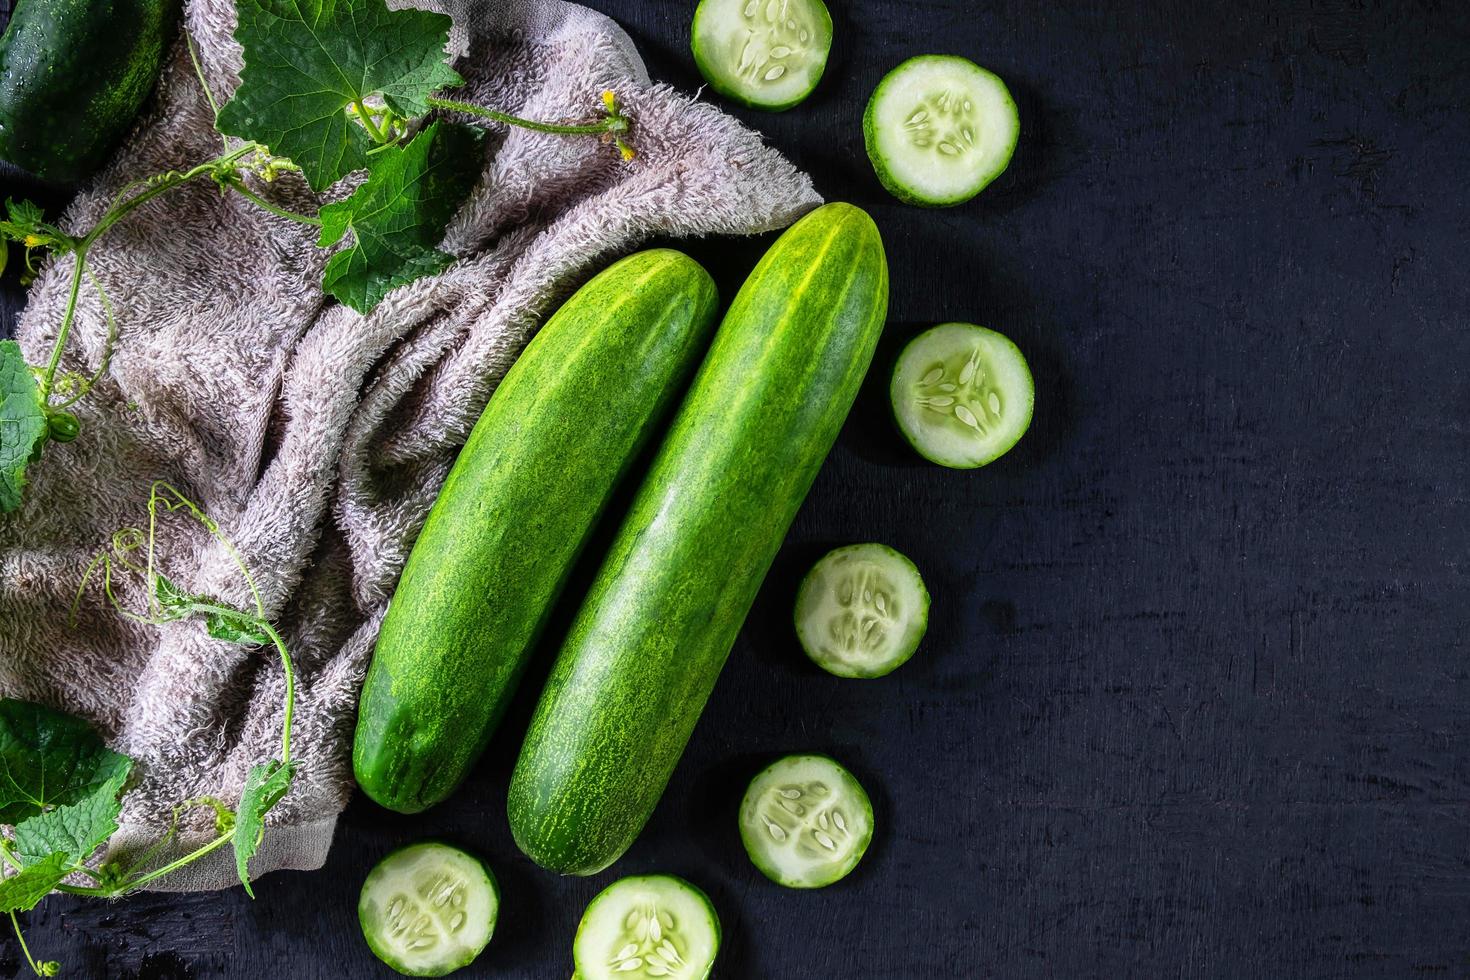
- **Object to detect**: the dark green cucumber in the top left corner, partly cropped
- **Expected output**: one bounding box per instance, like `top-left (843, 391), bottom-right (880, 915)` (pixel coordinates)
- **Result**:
top-left (0, 0), bottom-right (182, 184)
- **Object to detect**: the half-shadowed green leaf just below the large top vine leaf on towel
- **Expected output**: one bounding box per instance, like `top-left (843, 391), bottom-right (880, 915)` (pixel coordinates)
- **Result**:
top-left (318, 122), bottom-right (484, 313)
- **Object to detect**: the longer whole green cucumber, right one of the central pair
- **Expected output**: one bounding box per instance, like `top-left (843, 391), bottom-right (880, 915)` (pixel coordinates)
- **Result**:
top-left (507, 204), bottom-right (888, 874)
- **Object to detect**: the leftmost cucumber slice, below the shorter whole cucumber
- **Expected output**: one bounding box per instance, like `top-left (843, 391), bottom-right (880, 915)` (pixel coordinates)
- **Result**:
top-left (357, 840), bottom-right (500, 977)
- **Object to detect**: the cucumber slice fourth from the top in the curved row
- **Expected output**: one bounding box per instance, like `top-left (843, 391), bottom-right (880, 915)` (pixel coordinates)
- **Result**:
top-left (797, 544), bottom-right (929, 677)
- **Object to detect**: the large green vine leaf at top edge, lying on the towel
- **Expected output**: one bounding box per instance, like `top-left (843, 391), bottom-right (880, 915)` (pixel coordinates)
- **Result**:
top-left (216, 0), bottom-right (465, 191)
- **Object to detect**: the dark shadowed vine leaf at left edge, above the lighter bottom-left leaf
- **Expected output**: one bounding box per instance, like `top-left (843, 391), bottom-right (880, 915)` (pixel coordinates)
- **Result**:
top-left (0, 698), bottom-right (132, 824)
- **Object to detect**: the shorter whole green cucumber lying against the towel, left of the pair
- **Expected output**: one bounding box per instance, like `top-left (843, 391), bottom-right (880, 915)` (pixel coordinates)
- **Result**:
top-left (353, 248), bottom-right (719, 813)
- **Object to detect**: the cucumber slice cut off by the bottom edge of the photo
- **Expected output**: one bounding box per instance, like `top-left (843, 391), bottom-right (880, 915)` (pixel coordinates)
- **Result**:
top-left (572, 874), bottom-right (720, 980)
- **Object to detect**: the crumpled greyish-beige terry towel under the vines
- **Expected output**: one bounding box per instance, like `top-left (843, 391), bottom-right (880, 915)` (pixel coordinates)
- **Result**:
top-left (0, 0), bottom-right (817, 889)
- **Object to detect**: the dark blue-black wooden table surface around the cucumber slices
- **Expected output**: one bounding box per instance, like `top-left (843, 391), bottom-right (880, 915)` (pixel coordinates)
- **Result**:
top-left (0, 0), bottom-right (1470, 980)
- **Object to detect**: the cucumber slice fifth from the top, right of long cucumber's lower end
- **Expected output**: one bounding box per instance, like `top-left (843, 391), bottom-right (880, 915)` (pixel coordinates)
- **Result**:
top-left (739, 755), bottom-right (873, 887)
